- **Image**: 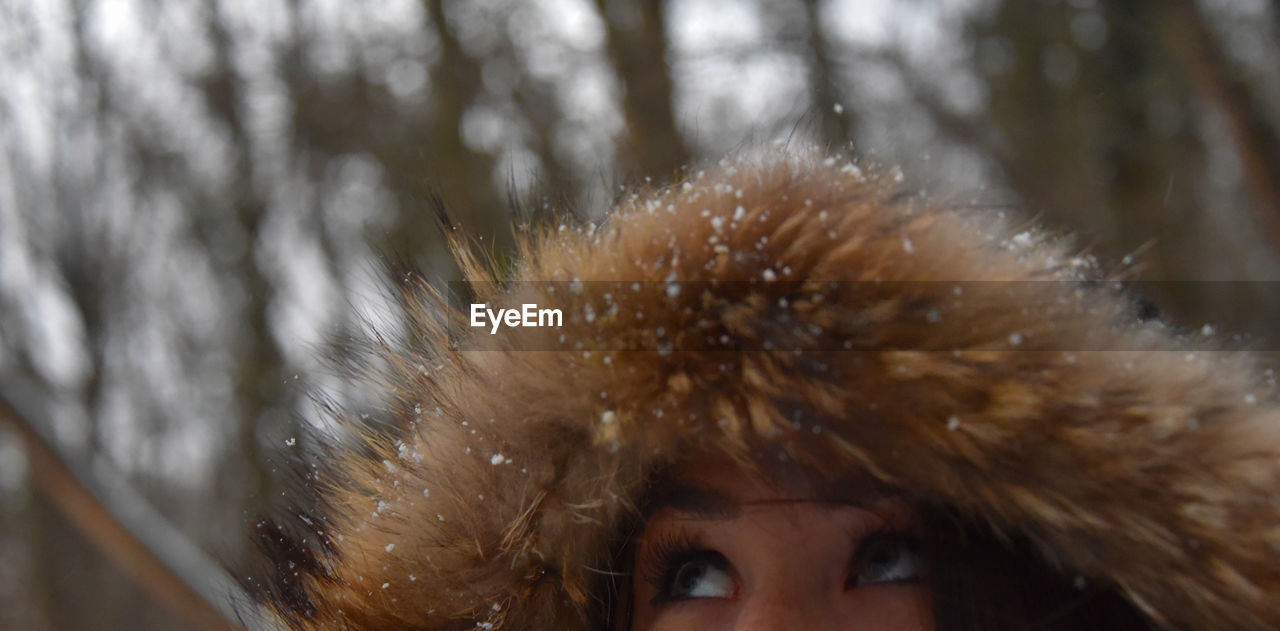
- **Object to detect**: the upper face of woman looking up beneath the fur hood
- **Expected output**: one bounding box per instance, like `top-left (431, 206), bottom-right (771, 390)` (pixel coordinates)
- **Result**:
top-left (631, 463), bottom-right (933, 631)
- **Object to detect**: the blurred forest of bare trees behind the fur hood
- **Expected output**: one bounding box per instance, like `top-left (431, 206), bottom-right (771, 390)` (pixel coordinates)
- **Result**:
top-left (0, 0), bottom-right (1280, 631)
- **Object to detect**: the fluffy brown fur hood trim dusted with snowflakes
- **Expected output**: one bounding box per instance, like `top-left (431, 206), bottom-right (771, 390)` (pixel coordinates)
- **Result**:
top-left (259, 154), bottom-right (1280, 631)
